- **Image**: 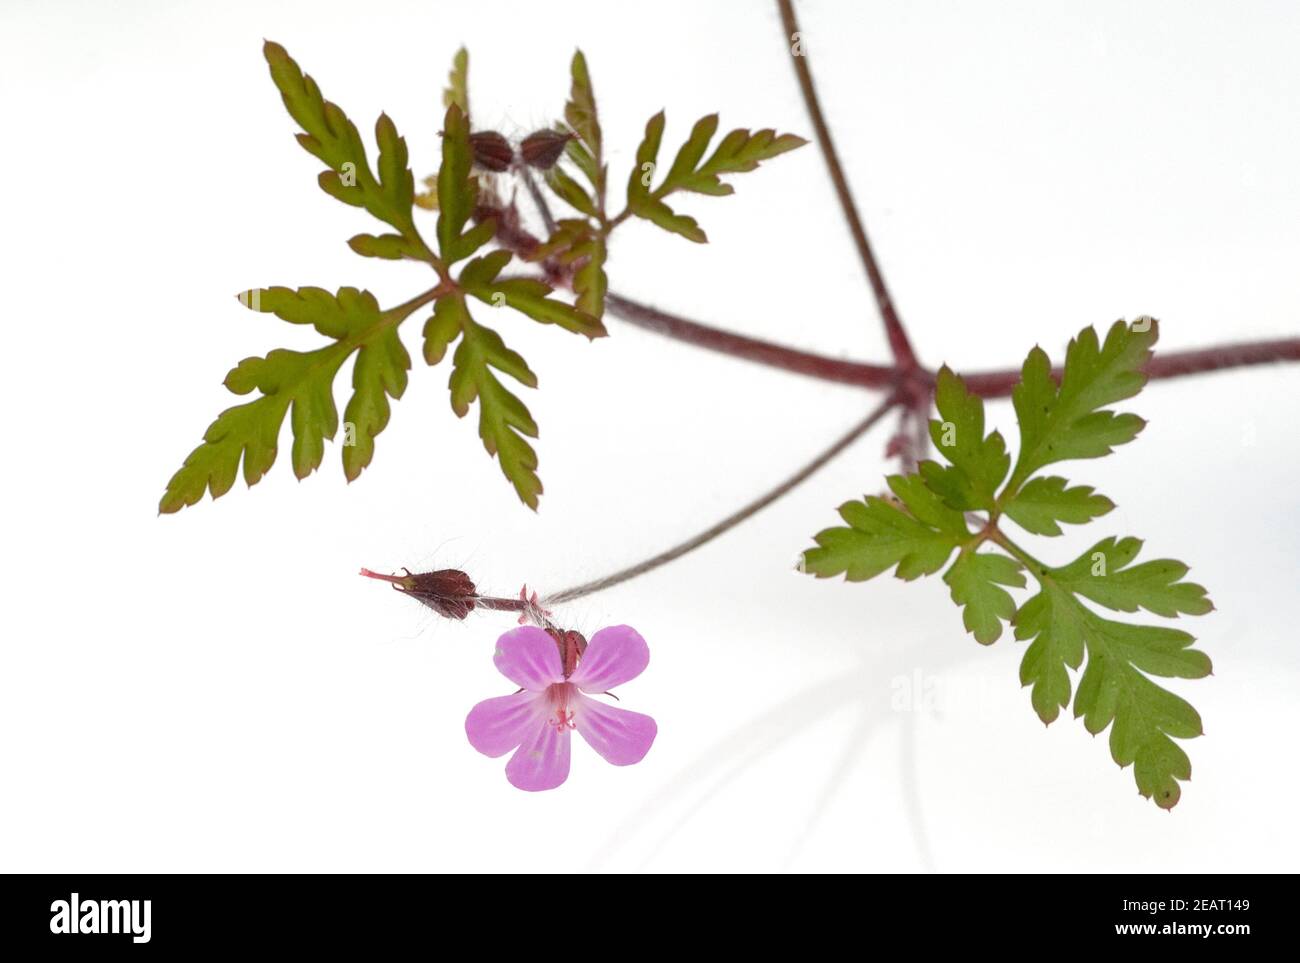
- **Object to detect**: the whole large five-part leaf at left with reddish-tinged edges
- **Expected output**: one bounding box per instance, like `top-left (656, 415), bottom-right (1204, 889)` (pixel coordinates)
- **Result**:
top-left (159, 42), bottom-right (605, 512)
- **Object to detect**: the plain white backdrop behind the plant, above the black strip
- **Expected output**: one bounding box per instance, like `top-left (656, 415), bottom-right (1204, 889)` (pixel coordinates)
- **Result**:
top-left (0, 0), bottom-right (1300, 872)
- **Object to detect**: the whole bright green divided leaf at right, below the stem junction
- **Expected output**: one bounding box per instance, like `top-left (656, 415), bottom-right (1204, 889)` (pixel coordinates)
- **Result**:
top-left (803, 318), bottom-right (1213, 808)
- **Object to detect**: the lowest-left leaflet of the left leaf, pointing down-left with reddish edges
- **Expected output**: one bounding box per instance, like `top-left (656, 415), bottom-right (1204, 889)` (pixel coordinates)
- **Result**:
top-left (159, 287), bottom-right (413, 512)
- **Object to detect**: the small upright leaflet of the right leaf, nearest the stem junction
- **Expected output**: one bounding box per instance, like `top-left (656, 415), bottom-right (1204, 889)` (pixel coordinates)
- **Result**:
top-left (919, 365), bottom-right (1011, 511)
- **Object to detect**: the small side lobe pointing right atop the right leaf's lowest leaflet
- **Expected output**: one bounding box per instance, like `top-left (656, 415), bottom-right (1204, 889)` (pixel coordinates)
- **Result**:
top-left (1053, 538), bottom-right (1214, 619)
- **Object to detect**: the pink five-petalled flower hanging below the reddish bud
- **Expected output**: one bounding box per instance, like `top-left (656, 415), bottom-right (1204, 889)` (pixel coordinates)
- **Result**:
top-left (465, 625), bottom-right (659, 791)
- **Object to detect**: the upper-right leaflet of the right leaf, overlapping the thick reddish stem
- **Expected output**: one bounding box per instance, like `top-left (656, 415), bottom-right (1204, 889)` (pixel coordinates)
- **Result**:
top-left (1008, 318), bottom-right (1160, 493)
